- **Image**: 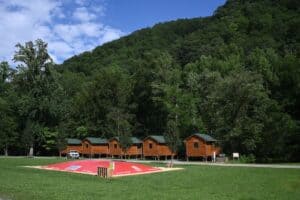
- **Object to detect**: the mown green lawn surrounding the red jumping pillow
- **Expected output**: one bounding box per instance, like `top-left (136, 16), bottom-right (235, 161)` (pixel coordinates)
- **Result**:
top-left (0, 158), bottom-right (300, 200)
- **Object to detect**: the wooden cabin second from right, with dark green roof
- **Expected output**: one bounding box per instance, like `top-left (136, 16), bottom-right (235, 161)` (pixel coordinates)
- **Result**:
top-left (143, 135), bottom-right (175, 159)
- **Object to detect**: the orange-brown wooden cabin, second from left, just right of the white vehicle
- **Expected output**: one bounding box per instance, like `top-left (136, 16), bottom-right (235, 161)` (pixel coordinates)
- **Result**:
top-left (82, 137), bottom-right (109, 157)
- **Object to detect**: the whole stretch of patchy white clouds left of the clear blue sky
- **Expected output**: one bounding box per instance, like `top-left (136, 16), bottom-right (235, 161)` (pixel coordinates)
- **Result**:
top-left (0, 0), bottom-right (124, 62)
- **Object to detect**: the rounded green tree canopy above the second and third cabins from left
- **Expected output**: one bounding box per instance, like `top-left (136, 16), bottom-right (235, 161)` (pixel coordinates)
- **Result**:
top-left (75, 67), bottom-right (134, 136)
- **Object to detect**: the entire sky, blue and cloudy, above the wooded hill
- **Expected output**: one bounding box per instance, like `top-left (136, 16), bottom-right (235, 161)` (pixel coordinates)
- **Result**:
top-left (0, 0), bottom-right (225, 63)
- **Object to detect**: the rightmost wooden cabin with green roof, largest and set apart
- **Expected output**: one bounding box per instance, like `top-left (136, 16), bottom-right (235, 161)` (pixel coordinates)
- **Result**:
top-left (184, 133), bottom-right (220, 159)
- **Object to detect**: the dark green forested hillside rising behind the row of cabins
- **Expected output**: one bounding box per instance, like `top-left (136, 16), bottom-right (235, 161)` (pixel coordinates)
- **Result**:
top-left (0, 0), bottom-right (300, 162)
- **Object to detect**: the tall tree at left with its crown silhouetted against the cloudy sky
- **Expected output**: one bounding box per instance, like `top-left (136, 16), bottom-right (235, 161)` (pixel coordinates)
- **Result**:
top-left (13, 39), bottom-right (53, 156)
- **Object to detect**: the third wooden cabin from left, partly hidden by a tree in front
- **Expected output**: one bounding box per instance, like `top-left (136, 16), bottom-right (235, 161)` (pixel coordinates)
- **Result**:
top-left (109, 137), bottom-right (142, 157)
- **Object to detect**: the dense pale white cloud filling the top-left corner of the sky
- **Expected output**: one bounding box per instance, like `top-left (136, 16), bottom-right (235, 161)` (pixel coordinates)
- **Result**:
top-left (0, 0), bottom-right (58, 61)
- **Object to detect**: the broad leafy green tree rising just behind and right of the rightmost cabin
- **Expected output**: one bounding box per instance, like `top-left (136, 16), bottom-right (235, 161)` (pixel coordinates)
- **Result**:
top-left (208, 71), bottom-right (271, 154)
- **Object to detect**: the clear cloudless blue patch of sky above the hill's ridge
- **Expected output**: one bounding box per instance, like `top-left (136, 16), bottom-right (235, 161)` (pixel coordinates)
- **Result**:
top-left (104, 0), bottom-right (225, 32)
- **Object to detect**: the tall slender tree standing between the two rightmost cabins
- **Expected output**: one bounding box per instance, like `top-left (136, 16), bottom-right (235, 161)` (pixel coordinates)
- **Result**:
top-left (152, 54), bottom-right (184, 165)
